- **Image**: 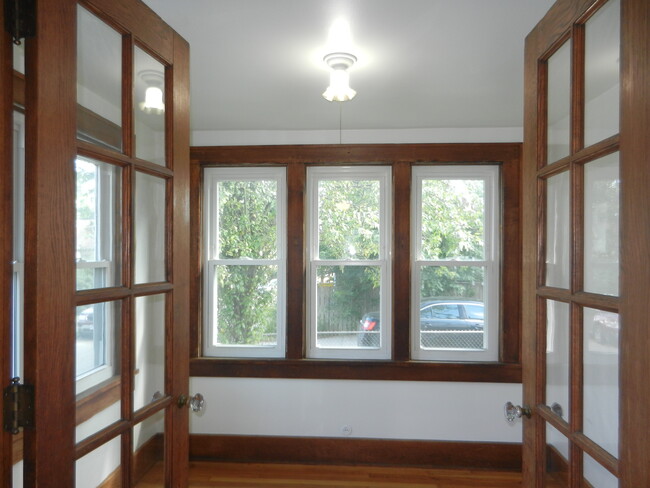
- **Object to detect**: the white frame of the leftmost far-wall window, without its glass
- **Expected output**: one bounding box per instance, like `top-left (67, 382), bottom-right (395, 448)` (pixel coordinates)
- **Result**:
top-left (203, 167), bottom-right (287, 358)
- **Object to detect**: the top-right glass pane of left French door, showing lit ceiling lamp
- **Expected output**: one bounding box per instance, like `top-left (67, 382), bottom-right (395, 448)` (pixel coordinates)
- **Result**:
top-left (133, 46), bottom-right (165, 166)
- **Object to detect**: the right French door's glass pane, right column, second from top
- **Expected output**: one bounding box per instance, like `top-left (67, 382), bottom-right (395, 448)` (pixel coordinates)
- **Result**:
top-left (584, 153), bottom-right (620, 295)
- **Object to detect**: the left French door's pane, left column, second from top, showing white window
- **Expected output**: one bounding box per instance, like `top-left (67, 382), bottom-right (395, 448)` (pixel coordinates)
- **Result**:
top-left (75, 157), bottom-right (122, 290)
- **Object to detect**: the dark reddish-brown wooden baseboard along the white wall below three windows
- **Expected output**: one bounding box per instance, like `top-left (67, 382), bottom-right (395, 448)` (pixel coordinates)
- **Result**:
top-left (190, 434), bottom-right (522, 471)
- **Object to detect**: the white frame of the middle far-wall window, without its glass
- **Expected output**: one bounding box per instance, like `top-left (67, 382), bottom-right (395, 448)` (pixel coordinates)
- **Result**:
top-left (305, 166), bottom-right (392, 359)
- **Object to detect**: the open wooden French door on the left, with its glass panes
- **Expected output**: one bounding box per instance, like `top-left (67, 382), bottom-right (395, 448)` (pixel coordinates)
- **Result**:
top-left (0, 0), bottom-right (189, 487)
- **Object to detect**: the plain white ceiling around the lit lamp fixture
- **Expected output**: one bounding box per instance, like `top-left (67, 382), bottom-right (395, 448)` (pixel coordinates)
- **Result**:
top-left (140, 0), bottom-right (554, 131)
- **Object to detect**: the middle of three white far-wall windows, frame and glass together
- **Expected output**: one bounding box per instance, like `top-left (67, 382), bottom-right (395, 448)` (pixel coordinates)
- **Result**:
top-left (306, 166), bottom-right (392, 359)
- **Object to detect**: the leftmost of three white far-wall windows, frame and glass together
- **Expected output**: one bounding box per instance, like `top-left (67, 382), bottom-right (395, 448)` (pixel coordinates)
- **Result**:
top-left (204, 167), bottom-right (287, 357)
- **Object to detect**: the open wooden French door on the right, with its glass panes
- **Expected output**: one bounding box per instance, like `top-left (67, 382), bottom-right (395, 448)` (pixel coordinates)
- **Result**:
top-left (523, 0), bottom-right (650, 488)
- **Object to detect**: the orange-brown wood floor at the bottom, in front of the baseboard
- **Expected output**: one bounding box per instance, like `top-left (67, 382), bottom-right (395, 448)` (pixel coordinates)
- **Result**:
top-left (138, 462), bottom-right (536, 488)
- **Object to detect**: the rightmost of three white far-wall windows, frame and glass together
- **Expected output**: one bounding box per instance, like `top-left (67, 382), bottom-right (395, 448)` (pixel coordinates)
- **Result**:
top-left (411, 165), bottom-right (500, 361)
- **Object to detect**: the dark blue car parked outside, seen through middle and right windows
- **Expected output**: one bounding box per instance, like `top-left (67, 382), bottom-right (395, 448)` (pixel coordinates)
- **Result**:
top-left (357, 299), bottom-right (484, 347)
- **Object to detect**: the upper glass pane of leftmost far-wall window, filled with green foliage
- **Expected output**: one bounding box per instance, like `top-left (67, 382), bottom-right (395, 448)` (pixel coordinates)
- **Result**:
top-left (216, 180), bottom-right (278, 259)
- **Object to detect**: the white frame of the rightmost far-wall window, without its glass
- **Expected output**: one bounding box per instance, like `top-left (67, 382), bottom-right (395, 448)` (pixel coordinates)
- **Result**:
top-left (410, 165), bottom-right (501, 361)
